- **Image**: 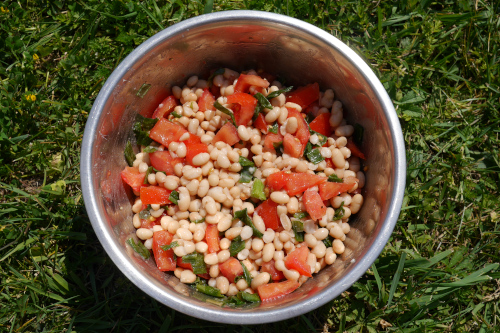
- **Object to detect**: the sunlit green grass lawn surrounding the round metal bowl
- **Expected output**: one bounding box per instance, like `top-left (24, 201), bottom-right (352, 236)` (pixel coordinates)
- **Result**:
top-left (0, 0), bottom-right (500, 332)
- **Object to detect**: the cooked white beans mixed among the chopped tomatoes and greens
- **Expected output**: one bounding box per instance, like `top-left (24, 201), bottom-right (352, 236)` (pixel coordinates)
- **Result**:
top-left (128, 69), bottom-right (365, 296)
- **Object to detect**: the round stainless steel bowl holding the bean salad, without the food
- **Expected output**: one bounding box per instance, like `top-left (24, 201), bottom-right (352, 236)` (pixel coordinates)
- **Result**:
top-left (81, 11), bottom-right (406, 324)
